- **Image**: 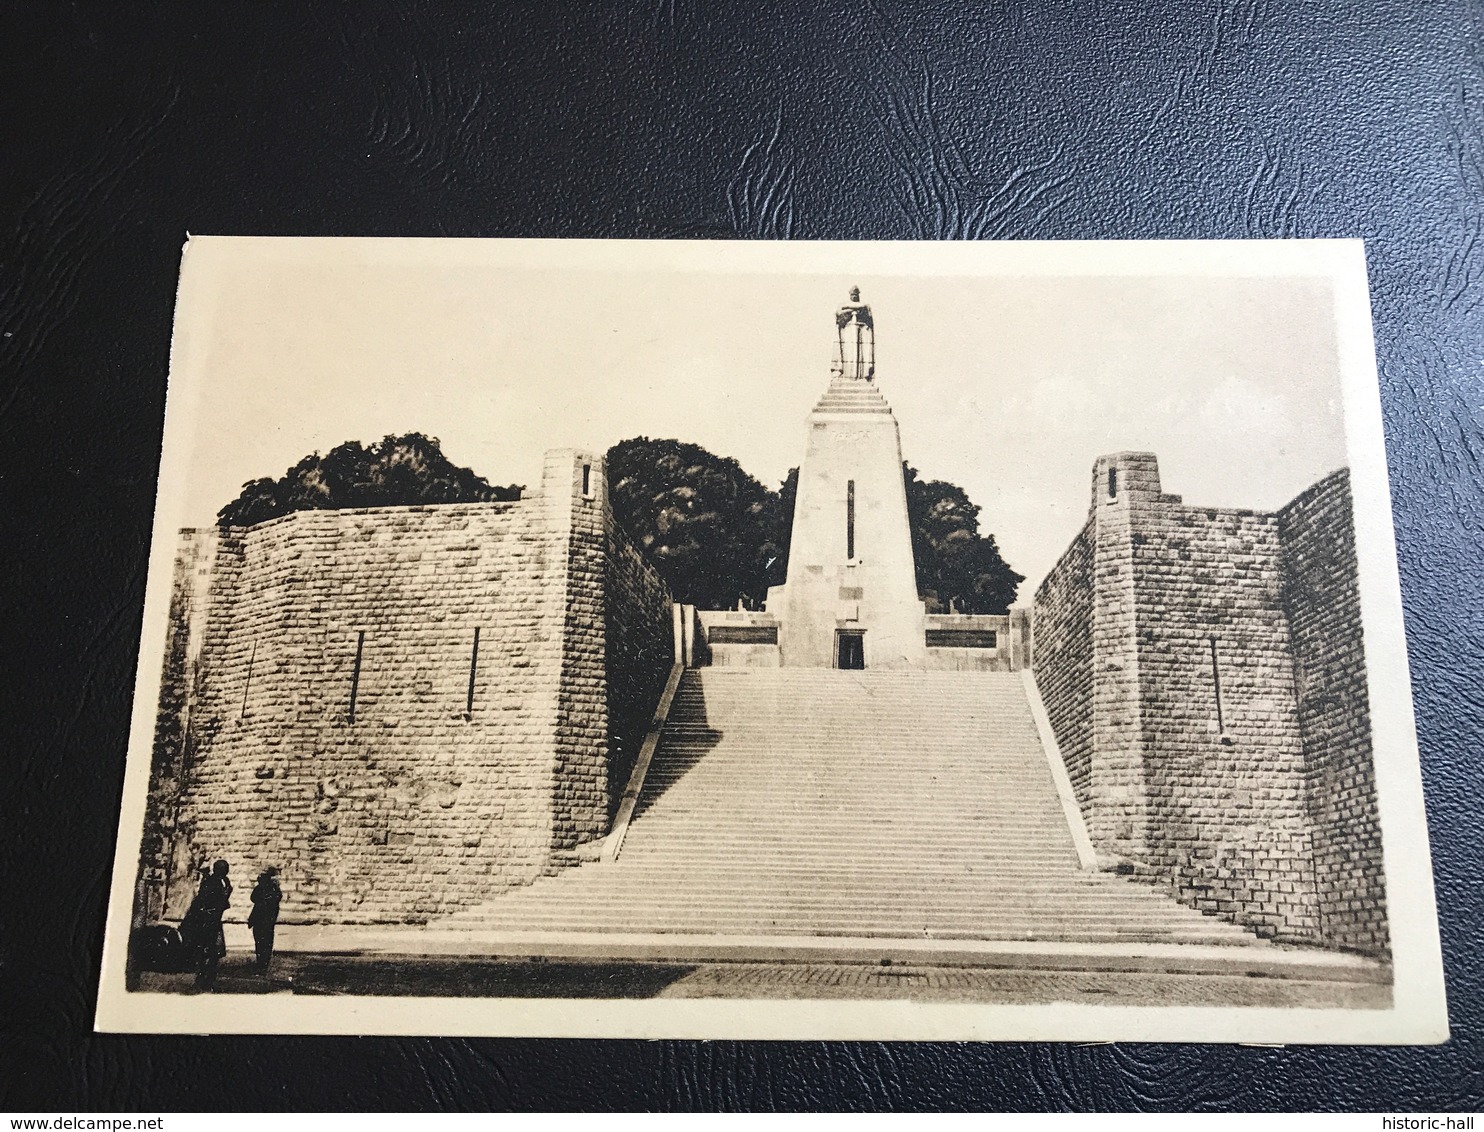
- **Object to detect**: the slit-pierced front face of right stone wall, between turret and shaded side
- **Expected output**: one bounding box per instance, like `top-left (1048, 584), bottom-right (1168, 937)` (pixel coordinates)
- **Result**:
top-left (1129, 492), bottom-right (1318, 941)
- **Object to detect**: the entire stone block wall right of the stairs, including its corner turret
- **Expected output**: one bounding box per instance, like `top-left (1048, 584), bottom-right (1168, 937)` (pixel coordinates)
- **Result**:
top-left (1033, 453), bottom-right (1386, 954)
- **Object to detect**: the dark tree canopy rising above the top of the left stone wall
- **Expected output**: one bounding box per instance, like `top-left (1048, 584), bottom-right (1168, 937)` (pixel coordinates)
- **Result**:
top-left (217, 432), bottom-right (524, 527)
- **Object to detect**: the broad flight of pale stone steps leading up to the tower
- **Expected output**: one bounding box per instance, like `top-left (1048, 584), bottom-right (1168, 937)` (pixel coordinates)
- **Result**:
top-left (430, 668), bottom-right (1267, 948)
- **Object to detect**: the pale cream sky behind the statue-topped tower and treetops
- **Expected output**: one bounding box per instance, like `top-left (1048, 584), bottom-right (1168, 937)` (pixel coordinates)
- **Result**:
top-left (170, 239), bottom-right (1346, 601)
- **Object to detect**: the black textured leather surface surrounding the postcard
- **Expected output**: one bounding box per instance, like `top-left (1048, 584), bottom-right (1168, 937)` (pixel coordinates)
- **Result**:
top-left (0, 0), bottom-right (1484, 1110)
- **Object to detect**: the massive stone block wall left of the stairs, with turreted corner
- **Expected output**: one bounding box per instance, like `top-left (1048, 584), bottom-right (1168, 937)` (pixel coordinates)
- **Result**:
top-left (141, 450), bottom-right (672, 923)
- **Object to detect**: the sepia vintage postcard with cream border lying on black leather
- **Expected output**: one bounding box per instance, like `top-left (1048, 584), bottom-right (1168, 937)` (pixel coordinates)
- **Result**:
top-left (98, 237), bottom-right (1447, 1043)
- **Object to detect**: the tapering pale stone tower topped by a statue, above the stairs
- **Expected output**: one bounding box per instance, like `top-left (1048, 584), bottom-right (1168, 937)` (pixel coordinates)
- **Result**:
top-left (767, 289), bottom-right (925, 668)
